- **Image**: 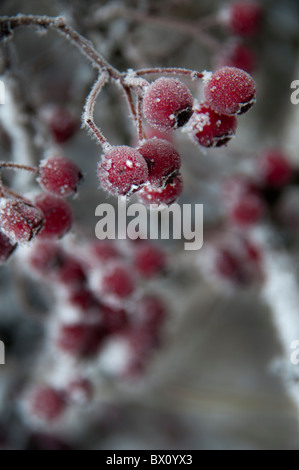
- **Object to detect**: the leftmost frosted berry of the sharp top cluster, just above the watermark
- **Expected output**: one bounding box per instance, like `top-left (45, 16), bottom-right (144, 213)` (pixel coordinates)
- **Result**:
top-left (98, 145), bottom-right (148, 196)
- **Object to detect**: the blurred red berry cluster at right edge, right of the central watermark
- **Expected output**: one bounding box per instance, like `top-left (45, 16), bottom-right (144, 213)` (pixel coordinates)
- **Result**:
top-left (223, 149), bottom-right (295, 228)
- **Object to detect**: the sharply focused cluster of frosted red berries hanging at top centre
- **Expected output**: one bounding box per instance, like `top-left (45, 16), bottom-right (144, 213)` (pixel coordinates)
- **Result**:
top-left (98, 67), bottom-right (256, 205)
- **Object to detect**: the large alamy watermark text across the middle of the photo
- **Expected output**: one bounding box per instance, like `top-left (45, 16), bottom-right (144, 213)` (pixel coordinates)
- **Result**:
top-left (95, 198), bottom-right (203, 250)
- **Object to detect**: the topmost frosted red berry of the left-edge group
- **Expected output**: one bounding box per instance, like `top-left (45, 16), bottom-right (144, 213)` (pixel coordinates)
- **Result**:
top-left (38, 156), bottom-right (82, 197)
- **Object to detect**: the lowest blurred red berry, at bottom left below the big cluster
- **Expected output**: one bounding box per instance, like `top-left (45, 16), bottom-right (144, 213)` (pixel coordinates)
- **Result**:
top-left (29, 385), bottom-right (66, 421)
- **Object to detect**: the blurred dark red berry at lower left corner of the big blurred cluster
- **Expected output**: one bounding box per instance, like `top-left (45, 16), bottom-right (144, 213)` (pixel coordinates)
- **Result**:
top-left (56, 323), bottom-right (106, 358)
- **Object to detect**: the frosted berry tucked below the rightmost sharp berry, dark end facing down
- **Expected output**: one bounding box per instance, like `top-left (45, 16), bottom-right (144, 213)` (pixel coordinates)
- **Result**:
top-left (186, 102), bottom-right (238, 147)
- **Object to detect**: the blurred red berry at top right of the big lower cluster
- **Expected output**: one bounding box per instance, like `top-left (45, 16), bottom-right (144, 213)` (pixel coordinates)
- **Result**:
top-left (134, 244), bottom-right (166, 278)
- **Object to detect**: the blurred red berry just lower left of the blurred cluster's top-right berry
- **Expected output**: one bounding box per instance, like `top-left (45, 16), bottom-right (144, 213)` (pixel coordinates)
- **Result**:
top-left (101, 264), bottom-right (135, 299)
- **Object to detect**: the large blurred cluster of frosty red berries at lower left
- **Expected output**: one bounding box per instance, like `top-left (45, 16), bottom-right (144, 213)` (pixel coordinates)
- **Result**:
top-left (21, 240), bottom-right (167, 422)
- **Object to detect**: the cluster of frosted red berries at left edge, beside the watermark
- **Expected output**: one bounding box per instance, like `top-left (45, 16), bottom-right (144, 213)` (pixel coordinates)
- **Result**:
top-left (0, 156), bottom-right (82, 262)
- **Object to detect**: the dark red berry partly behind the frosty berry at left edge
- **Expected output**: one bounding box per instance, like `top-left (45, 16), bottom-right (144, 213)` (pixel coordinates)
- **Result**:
top-left (35, 193), bottom-right (73, 238)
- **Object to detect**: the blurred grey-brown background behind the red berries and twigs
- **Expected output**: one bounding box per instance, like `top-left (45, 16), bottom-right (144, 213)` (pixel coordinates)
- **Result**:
top-left (0, 0), bottom-right (299, 450)
